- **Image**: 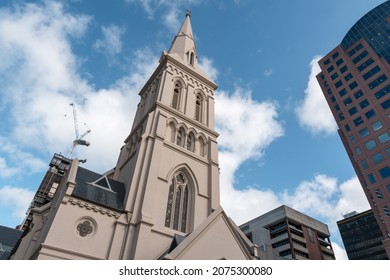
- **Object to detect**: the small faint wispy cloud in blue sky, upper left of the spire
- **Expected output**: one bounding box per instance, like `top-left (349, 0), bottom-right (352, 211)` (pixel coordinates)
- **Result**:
top-left (94, 24), bottom-right (125, 56)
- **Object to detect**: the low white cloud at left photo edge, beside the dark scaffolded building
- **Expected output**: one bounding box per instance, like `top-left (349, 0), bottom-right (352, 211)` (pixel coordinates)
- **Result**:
top-left (0, 186), bottom-right (35, 220)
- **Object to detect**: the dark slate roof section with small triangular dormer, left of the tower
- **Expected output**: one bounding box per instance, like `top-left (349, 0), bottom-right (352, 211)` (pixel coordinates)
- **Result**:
top-left (72, 166), bottom-right (125, 211)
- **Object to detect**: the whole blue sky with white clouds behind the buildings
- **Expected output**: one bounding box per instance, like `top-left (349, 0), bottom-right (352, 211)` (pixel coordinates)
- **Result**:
top-left (0, 0), bottom-right (383, 259)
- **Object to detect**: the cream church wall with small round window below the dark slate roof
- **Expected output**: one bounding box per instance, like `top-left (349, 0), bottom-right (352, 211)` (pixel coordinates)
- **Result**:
top-left (41, 198), bottom-right (119, 259)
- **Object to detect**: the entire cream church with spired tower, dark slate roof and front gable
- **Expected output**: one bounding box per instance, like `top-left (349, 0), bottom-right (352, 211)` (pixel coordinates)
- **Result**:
top-left (11, 12), bottom-right (259, 260)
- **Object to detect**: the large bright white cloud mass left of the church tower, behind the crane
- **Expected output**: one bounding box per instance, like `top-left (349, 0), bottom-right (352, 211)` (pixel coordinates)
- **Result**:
top-left (0, 2), bottom-right (158, 172)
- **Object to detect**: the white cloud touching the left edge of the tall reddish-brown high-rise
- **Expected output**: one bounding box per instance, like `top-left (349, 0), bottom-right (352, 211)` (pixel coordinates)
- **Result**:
top-left (295, 56), bottom-right (337, 134)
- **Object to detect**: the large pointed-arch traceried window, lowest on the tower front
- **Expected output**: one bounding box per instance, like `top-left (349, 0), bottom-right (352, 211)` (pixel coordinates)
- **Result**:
top-left (165, 171), bottom-right (190, 232)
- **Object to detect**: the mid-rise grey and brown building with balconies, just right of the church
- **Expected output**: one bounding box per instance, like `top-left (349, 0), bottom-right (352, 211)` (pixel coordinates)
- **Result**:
top-left (240, 205), bottom-right (335, 260)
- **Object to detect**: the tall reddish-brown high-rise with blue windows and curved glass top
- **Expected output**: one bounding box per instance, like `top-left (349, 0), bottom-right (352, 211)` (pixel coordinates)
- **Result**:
top-left (317, 1), bottom-right (390, 256)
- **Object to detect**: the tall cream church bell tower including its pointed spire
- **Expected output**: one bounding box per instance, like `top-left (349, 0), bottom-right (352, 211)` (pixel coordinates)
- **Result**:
top-left (113, 12), bottom-right (220, 259)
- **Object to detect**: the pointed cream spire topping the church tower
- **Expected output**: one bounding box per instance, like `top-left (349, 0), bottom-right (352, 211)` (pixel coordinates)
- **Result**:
top-left (168, 10), bottom-right (198, 67)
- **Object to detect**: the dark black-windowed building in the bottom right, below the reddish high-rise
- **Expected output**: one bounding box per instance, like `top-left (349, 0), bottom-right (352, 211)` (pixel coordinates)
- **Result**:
top-left (337, 209), bottom-right (389, 260)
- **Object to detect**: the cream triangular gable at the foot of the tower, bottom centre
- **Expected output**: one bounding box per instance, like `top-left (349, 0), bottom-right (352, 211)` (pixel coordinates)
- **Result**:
top-left (161, 207), bottom-right (257, 260)
